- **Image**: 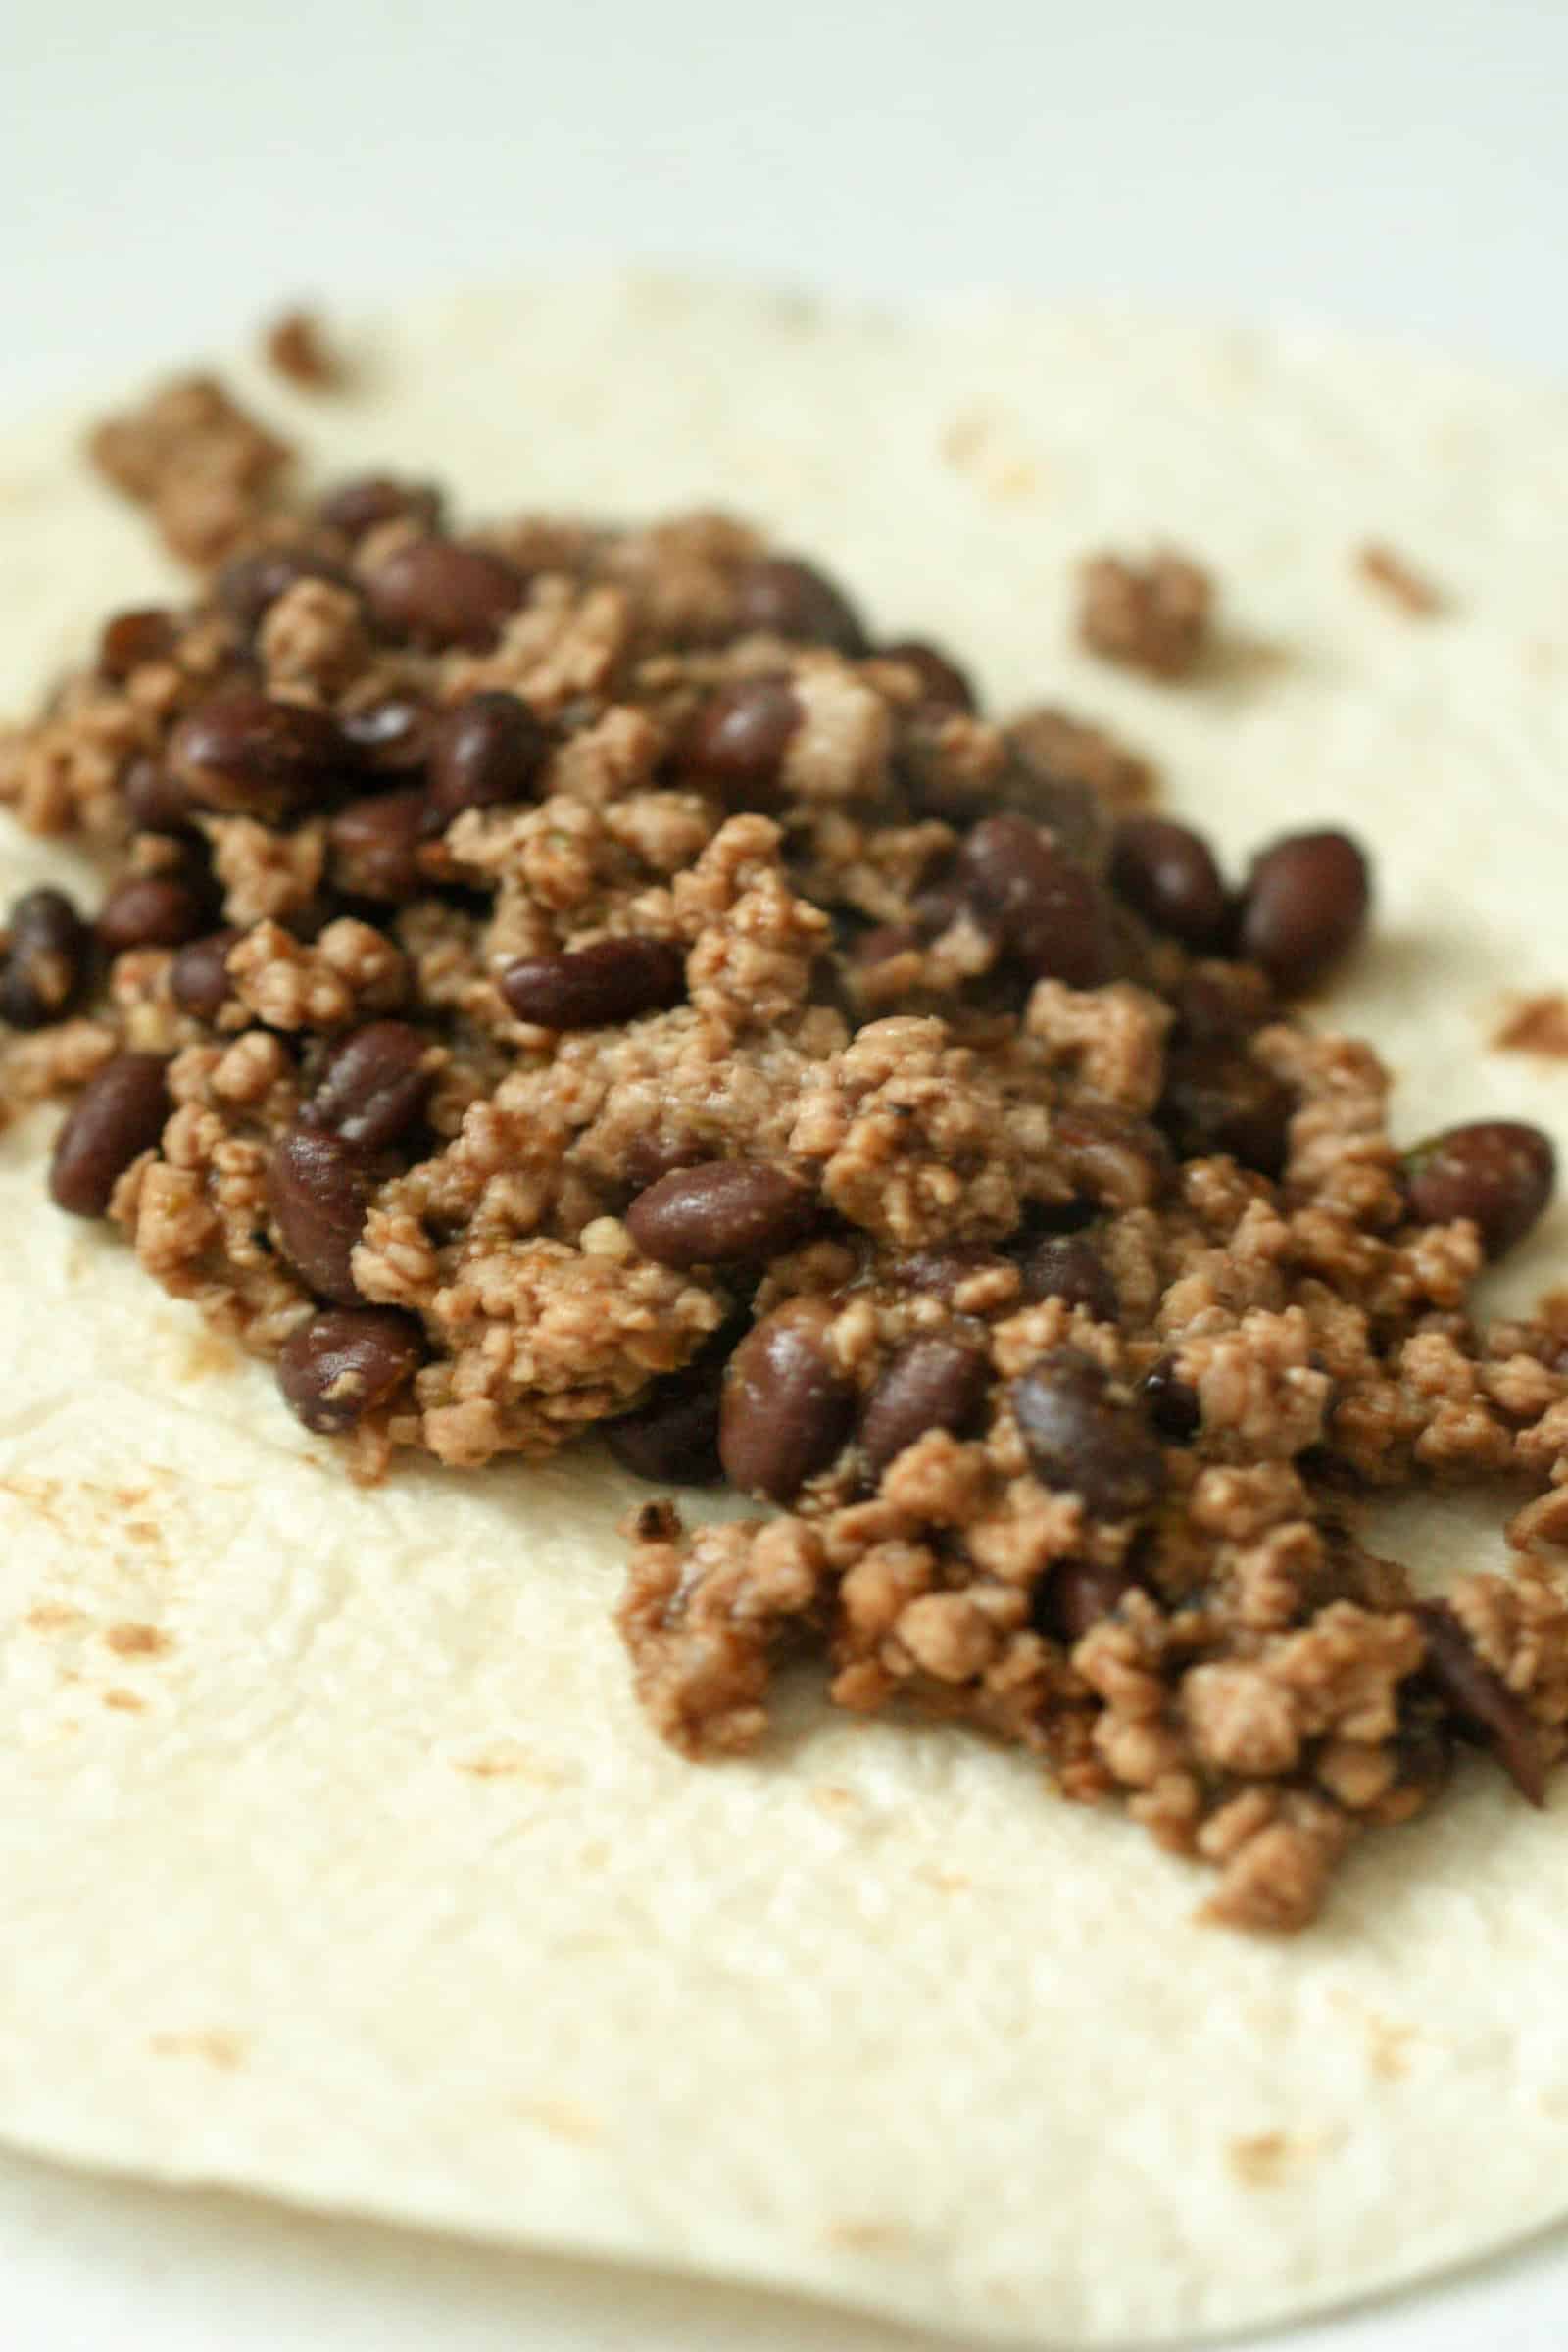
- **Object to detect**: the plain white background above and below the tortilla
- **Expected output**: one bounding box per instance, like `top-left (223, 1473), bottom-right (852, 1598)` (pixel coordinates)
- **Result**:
top-left (0, 0), bottom-right (1568, 2352)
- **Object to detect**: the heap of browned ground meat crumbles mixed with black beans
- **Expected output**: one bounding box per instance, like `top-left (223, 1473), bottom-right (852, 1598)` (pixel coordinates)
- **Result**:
top-left (0, 378), bottom-right (1568, 1929)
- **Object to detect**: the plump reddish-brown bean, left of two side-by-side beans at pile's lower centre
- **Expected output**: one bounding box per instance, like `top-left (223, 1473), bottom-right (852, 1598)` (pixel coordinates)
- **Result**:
top-left (719, 1298), bottom-right (856, 1503)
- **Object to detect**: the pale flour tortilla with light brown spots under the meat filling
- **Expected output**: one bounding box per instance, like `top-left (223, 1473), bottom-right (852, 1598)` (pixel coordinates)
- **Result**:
top-left (0, 282), bottom-right (1568, 2345)
